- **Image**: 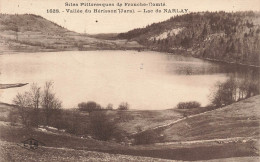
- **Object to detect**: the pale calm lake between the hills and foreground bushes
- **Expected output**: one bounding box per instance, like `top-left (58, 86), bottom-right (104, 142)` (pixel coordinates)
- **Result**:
top-left (0, 51), bottom-right (258, 110)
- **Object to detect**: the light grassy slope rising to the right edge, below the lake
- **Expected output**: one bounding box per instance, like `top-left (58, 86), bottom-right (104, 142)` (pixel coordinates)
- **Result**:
top-left (162, 95), bottom-right (260, 141)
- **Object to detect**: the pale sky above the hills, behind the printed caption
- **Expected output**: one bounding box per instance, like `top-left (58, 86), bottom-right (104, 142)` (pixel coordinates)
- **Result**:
top-left (0, 0), bottom-right (260, 34)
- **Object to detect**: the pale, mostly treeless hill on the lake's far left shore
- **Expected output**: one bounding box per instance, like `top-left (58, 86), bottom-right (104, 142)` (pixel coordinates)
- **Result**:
top-left (0, 14), bottom-right (142, 54)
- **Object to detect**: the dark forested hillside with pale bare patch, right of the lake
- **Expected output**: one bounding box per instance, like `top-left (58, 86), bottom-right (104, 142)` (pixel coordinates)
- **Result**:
top-left (118, 11), bottom-right (260, 66)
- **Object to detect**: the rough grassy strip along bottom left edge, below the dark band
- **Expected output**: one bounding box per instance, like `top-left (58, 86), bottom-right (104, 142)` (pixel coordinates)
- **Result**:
top-left (0, 141), bottom-right (173, 162)
